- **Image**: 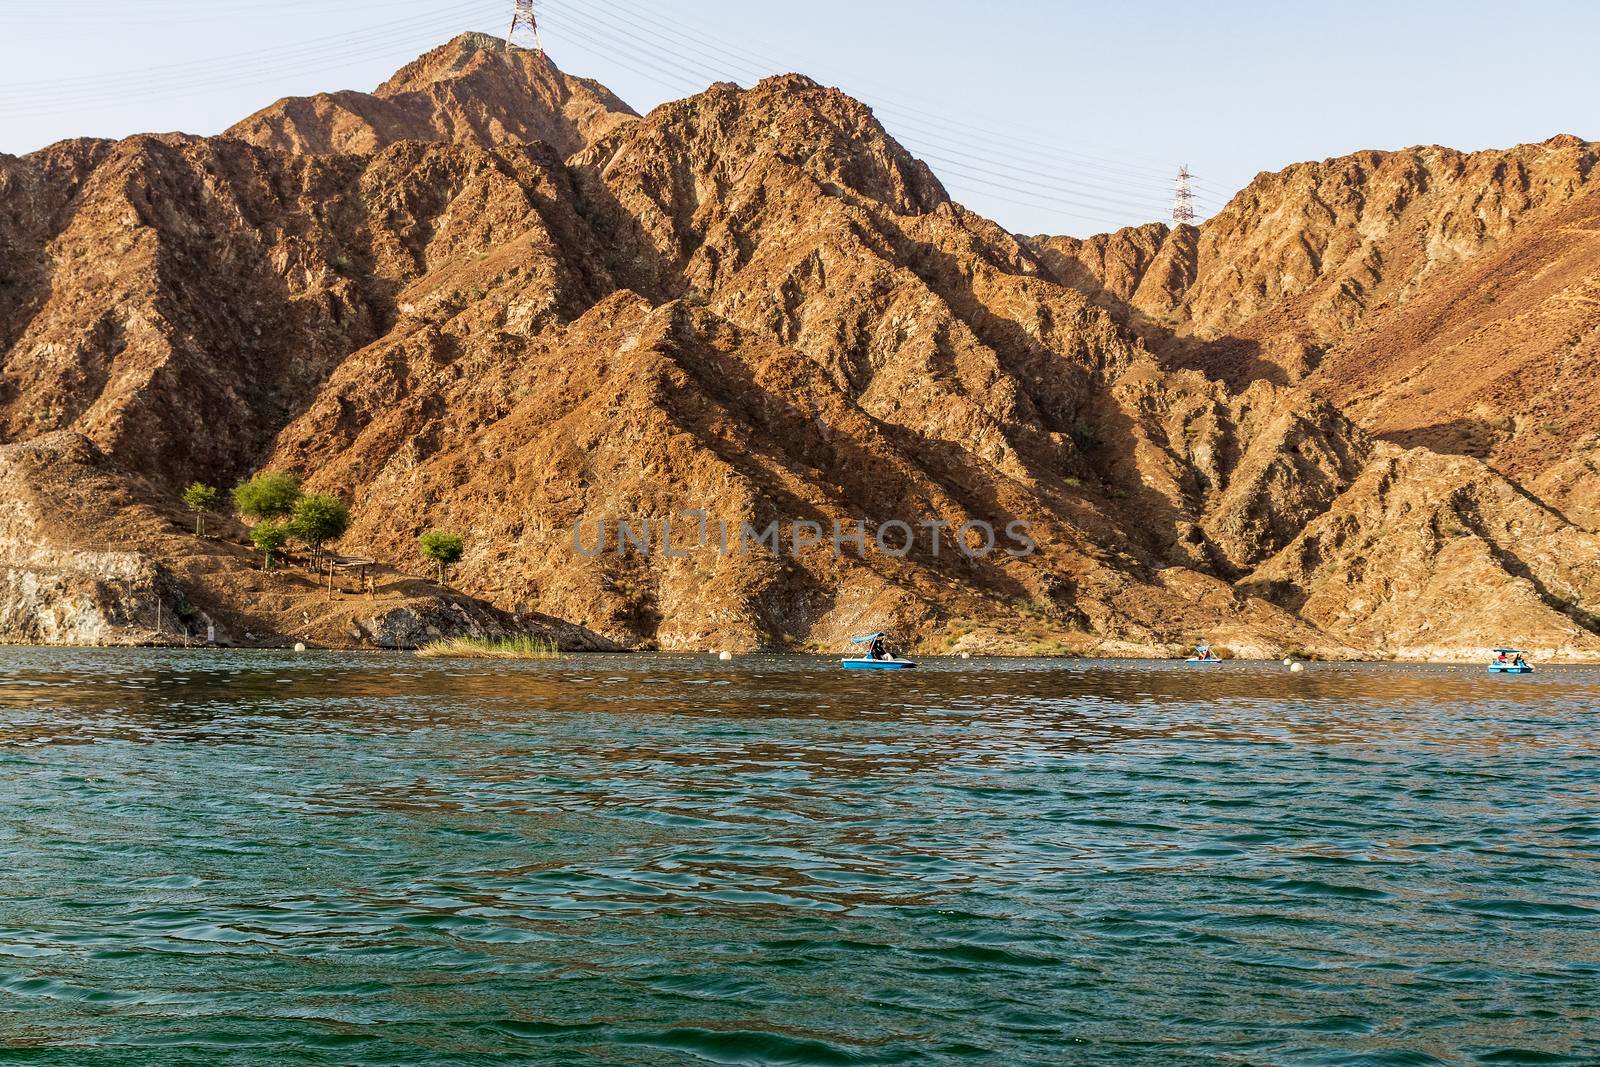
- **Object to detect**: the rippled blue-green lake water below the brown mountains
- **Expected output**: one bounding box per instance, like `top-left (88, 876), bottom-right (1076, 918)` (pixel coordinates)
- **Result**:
top-left (0, 649), bottom-right (1600, 1065)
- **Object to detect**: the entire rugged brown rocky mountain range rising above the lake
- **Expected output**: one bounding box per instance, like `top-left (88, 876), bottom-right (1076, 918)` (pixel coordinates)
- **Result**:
top-left (0, 35), bottom-right (1600, 659)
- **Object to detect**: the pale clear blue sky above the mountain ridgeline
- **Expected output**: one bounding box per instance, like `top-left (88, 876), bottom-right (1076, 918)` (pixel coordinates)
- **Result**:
top-left (0, 0), bottom-right (1600, 235)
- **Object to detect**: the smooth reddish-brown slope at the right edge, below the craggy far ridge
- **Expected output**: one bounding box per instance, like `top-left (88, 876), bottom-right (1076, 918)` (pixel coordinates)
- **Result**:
top-left (1307, 184), bottom-right (1600, 528)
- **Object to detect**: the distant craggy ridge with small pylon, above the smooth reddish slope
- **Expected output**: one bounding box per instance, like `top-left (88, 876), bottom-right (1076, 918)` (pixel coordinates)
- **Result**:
top-left (1032, 134), bottom-right (1600, 363)
